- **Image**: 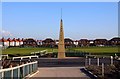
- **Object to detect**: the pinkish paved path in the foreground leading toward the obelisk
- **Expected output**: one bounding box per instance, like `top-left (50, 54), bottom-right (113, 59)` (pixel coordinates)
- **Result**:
top-left (30, 67), bottom-right (90, 79)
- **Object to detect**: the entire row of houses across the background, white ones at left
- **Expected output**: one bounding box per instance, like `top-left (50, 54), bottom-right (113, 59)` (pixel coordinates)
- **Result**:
top-left (0, 37), bottom-right (120, 47)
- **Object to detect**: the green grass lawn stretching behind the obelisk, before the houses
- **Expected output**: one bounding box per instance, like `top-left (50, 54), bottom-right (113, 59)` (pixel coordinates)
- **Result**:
top-left (2, 47), bottom-right (120, 55)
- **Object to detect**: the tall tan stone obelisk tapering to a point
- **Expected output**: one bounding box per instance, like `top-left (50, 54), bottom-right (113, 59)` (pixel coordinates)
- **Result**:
top-left (58, 10), bottom-right (65, 58)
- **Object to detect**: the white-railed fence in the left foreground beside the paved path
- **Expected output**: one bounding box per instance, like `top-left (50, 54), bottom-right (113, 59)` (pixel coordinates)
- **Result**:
top-left (0, 61), bottom-right (38, 79)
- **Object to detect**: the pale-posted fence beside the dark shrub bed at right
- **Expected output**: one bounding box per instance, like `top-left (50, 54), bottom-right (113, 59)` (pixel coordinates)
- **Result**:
top-left (85, 55), bottom-right (114, 79)
